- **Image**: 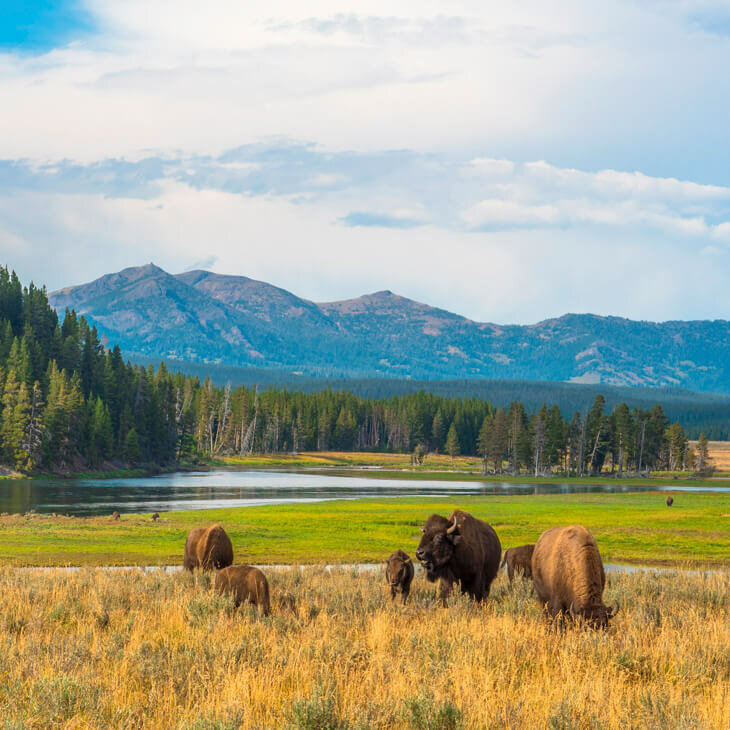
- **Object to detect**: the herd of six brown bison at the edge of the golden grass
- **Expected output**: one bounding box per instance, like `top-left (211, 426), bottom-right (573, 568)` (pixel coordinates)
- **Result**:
top-left (183, 510), bottom-right (616, 628)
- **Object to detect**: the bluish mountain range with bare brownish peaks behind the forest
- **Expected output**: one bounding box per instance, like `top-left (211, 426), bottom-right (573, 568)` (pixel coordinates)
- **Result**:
top-left (50, 264), bottom-right (730, 393)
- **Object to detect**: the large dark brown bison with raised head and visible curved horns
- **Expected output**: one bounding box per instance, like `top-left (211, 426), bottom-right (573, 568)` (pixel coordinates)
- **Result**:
top-left (416, 510), bottom-right (502, 606)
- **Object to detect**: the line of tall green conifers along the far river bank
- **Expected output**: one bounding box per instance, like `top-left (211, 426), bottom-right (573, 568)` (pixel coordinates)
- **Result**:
top-left (0, 268), bottom-right (709, 475)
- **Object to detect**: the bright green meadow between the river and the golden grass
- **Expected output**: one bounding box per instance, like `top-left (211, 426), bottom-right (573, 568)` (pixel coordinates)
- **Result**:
top-left (0, 492), bottom-right (730, 566)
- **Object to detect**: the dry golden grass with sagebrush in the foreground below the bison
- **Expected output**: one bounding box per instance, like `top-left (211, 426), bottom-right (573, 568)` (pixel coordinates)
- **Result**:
top-left (0, 568), bottom-right (730, 730)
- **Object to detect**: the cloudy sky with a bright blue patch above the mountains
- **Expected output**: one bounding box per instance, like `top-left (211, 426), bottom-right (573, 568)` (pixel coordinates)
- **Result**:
top-left (0, 0), bottom-right (730, 323)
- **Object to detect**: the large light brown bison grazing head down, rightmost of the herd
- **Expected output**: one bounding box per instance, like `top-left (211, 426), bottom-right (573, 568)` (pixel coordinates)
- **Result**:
top-left (532, 525), bottom-right (617, 628)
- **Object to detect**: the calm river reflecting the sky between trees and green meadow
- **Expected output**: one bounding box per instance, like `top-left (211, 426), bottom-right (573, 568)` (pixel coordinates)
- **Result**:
top-left (0, 470), bottom-right (716, 516)
